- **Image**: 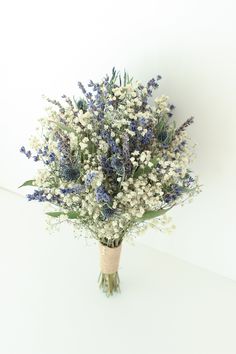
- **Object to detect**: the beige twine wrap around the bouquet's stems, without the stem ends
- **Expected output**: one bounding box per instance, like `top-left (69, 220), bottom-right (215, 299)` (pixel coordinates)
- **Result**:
top-left (99, 243), bottom-right (121, 274)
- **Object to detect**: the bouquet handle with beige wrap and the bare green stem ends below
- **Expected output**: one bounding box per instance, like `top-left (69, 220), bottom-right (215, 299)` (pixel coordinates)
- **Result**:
top-left (98, 243), bottom-right (122, 296)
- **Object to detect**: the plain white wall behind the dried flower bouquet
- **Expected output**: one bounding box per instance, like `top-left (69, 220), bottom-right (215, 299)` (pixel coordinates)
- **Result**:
top-left (0, 0), bottom-right (236, 279)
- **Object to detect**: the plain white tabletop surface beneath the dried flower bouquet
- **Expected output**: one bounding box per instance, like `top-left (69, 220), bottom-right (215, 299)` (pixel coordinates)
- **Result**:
top-left (0, 190), bottom-right (236, 354)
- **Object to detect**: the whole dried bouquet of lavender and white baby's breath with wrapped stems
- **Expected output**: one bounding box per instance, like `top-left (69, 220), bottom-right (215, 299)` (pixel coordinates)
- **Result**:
top-left (21, 69), bottom-right (199, 295)
